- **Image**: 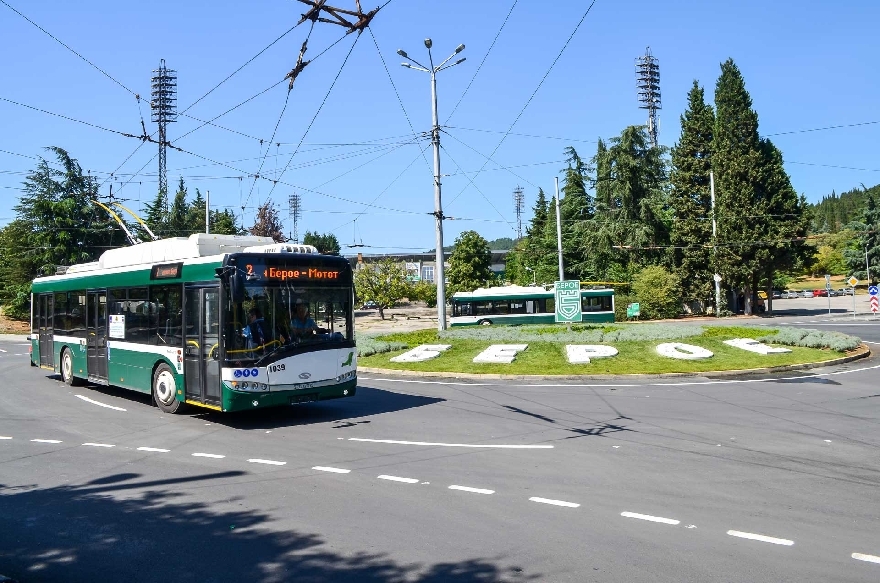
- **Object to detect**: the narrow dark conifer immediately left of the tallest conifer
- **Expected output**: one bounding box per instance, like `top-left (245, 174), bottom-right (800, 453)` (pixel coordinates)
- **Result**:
top-left (670, 81), bottom-right (715, 302)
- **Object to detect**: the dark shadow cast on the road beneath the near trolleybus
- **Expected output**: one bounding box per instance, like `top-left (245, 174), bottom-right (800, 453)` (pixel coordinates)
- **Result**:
top-left (196, 386), bottom-right (445, 429)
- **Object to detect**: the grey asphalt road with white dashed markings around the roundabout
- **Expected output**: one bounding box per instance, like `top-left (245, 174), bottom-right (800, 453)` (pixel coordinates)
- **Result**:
top-left (0, 322), bottom-right (880, 583)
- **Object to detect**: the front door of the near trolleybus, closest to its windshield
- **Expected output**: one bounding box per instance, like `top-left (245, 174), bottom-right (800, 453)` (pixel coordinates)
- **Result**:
top-left (183, 287), bottom-right (220, 405)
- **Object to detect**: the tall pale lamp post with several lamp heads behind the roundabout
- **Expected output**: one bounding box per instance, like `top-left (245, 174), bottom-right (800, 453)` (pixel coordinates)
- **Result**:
top-left (397, 38), bottom-right (465, 331)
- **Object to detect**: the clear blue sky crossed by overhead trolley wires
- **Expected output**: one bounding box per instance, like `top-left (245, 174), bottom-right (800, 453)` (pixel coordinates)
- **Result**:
top-left (0, 0), bottom-right (880, 253)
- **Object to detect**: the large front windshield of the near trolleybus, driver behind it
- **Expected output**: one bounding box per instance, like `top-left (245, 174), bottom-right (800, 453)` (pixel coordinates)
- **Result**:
top-left (225, 278), bottom-right (353, 366)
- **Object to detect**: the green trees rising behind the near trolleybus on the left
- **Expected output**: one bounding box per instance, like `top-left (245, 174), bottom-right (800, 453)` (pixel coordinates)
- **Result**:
top-left (0, 147), bottom-right (340, 318)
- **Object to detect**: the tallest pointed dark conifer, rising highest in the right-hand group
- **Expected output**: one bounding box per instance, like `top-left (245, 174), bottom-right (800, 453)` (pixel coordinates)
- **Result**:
top-left (712, 59), bottom-right (768, 314)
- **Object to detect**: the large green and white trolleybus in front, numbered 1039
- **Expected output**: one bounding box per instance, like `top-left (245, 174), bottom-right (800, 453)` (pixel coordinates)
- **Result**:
top-left (31, 234), bottom-right (357, 413)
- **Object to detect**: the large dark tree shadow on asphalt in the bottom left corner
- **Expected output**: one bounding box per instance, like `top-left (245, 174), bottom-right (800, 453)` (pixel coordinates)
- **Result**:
top-left (0, 471), bottom-right (541, 583)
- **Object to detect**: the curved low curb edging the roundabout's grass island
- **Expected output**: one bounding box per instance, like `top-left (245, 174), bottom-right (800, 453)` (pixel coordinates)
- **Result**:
top-left (358, 344), bottom-right (871, 381)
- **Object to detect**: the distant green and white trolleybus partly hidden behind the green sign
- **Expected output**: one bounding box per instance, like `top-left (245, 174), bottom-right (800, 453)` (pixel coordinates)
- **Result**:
top-left (450, 285), bottom-right (614, 326)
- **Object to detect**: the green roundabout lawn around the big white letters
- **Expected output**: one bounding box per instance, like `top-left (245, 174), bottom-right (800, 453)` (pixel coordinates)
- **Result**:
top-left (358, 327), bottom-right (842, 375)
